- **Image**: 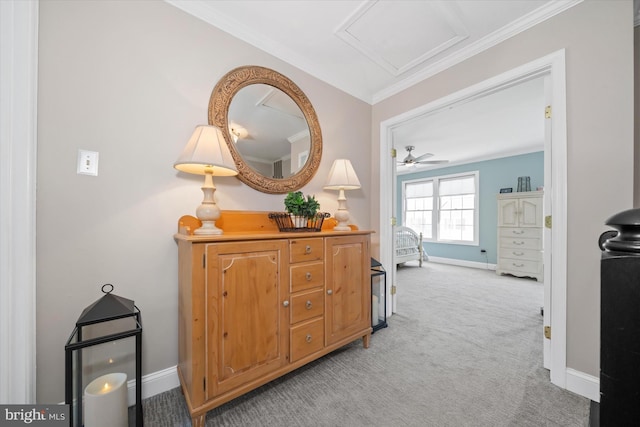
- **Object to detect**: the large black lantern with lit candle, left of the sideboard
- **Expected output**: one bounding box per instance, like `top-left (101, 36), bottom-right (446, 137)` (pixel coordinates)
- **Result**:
top-left (64, 284), bottom-right (143, 427)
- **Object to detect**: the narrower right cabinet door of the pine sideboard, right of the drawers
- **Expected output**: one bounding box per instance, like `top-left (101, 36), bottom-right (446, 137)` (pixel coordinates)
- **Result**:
top-left (325, 235), bottom-right (371, 345)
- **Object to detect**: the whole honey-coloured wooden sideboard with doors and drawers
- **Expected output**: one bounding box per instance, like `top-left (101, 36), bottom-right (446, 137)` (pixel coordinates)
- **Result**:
top-left (175, 212), bottom-right (371, 426)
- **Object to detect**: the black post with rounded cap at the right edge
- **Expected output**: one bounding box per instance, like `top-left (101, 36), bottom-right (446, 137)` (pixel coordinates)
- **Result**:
top-left (599, 209), bottom-right (640, 427)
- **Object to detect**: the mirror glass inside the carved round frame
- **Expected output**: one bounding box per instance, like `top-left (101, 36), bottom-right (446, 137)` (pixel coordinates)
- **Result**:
top-left (228, 84), bottom-right (310, 179)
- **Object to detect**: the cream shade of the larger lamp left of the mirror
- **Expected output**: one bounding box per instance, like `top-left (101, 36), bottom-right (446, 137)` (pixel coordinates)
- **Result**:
top-left (173, 125), bottom-right (238, 176)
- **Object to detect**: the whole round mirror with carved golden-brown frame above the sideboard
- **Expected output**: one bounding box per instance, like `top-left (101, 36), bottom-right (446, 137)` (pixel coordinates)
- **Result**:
top-left (209, 66), bottom-right (322, 194)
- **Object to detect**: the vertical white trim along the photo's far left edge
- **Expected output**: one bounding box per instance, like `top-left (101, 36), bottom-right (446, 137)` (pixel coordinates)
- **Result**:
top-left (0, 0), bottom-right (39, 404)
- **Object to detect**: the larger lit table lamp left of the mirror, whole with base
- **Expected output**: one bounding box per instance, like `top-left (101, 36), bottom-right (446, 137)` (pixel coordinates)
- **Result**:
top-left (173, 125), bottom-right (238, 235)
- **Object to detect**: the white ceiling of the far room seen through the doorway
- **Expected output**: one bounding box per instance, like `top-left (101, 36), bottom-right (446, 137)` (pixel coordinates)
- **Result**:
top-left (392, 77), bottom-right (545, 174)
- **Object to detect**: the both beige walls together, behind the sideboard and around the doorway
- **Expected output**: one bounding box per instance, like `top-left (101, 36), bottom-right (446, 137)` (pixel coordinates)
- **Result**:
top-left (37, 0), bottom-right (633, 402)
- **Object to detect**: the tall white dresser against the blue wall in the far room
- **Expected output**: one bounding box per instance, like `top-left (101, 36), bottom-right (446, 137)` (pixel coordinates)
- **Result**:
top-left (496, 191), bottom-right (544, 281)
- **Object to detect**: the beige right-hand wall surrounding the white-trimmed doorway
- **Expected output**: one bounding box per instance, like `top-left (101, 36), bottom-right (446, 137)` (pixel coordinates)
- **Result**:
top-left (371, 0), bottom-right (633, 376)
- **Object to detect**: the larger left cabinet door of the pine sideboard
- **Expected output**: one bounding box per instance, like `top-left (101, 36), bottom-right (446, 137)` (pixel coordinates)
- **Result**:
top-left (207, 240), bottom-right (289, 397)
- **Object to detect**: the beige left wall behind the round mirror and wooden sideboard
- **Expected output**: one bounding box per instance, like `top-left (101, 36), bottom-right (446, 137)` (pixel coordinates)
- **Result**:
top-left (37, 0), bottom-right (371, 402)
